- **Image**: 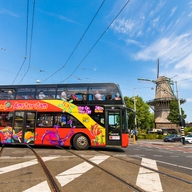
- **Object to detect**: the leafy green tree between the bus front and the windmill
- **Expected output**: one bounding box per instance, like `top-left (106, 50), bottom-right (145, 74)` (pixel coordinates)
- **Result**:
top-left (124, 96), bottom-right (155, 129)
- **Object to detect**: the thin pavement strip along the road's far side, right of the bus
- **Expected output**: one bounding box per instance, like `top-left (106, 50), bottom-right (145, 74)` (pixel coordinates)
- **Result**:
top-left (129, 138), bottom-right (192, 148)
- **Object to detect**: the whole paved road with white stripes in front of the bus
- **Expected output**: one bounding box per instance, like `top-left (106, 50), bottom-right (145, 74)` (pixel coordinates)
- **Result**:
top-left (0, 140), bottom-right (192, 192)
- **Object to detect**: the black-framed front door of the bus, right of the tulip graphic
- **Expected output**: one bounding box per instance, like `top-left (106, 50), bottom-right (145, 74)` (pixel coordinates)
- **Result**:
top-left (105, 109), bottom-right (122, 146)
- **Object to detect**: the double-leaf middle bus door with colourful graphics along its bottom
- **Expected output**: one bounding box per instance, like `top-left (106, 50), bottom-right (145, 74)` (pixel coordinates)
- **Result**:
top-left (13, 111), bottom-right (37, 144)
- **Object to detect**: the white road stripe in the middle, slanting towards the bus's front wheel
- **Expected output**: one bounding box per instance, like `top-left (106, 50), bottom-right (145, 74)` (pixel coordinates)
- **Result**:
top-left (56, 156), bottom-right (109, 187)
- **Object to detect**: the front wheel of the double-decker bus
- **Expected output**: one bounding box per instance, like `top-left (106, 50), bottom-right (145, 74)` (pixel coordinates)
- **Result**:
top-left (73, 134), bottom-right (89, 150)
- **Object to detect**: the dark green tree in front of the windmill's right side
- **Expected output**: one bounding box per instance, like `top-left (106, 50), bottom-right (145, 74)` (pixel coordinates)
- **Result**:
top-left (167, 100), bottom-right (187, 125)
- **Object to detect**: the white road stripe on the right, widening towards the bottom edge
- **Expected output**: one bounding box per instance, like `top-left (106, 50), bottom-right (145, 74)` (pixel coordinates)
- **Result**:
top-left (136, 158), bottom-right (163, 192)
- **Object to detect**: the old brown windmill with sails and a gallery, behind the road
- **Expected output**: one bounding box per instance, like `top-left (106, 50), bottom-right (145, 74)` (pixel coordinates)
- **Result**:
top-left (138, 60), bottom-right (186, 129)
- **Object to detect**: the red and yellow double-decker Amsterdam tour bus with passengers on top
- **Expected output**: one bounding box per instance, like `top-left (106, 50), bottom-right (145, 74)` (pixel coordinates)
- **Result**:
top-left (0, 83), bottom-right (129, 150)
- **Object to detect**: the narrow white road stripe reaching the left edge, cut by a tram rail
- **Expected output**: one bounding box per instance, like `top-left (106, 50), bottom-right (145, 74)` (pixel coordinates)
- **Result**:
top-left (0, 156), bottom-right (59, 175)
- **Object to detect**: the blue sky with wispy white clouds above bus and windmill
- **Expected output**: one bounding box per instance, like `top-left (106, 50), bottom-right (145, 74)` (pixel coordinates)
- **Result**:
top-left (0, 0), bottom-right (192, 122)
